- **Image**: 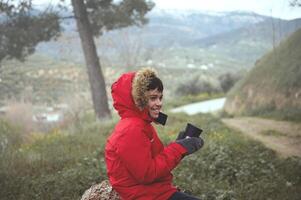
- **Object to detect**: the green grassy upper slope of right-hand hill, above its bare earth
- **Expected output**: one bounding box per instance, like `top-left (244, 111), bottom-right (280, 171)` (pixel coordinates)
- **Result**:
top-left (233, 30), bottom-right (301, 92)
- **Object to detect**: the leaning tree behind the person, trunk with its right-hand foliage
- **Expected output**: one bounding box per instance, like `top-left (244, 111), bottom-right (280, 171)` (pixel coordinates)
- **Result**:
top-left (1, 0), bottom-right (154, 119)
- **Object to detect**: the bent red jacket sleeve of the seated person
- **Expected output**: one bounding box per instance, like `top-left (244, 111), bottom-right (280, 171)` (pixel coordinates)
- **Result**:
top-left (117, 127), bottom-right (187, 184)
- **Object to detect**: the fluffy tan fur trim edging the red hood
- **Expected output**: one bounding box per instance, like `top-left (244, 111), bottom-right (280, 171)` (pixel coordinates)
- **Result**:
top-left (132, 68), bottom-right (157, 110)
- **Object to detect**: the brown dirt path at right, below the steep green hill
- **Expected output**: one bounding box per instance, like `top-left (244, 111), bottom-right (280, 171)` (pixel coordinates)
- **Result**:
top-left (222, 117), bottom-right (301, 157)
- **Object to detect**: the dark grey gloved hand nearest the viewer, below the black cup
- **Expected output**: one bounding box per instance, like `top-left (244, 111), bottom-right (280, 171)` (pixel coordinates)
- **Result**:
top-left (176, 137), bottom-right (204, 155)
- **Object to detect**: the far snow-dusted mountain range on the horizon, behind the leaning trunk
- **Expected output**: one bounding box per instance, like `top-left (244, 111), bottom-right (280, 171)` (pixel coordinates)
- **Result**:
top-left (37, 9), bottom-right (268, 61)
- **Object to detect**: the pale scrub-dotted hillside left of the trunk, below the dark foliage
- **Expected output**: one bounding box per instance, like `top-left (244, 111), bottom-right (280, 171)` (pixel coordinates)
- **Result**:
top-left (0, 54), bottom-right (89, 106)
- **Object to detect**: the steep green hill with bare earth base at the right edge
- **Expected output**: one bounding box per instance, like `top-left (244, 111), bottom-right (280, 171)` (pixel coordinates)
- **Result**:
top-left (225, 29), bottom-right (301, 121)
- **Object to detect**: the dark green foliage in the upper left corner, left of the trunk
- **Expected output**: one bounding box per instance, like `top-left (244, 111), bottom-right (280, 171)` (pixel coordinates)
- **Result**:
top-left (0, 0), bottom-right (60, 62)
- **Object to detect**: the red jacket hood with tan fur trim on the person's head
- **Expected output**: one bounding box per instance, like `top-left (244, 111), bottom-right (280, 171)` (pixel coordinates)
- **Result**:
top-left (111, 68), bottom-right (157, 120)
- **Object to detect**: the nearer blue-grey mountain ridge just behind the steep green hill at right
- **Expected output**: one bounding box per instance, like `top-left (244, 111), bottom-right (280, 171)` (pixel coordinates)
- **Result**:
top-left (191, 18), bottom-right (301, 62)
